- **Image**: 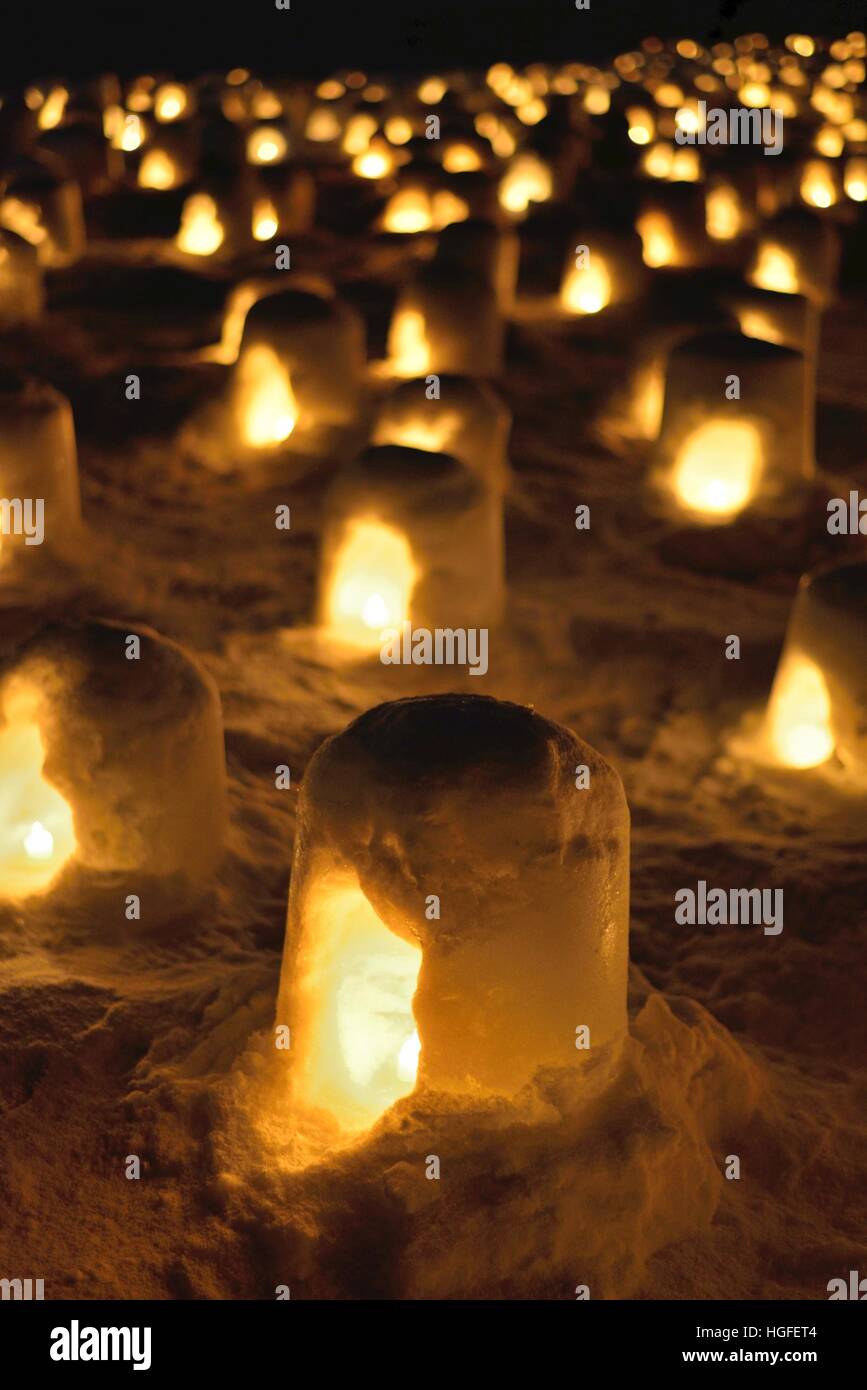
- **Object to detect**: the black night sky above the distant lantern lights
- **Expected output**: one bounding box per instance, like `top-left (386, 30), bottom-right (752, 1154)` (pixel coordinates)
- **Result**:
top-left (0, 0), bottom-right (864, 85)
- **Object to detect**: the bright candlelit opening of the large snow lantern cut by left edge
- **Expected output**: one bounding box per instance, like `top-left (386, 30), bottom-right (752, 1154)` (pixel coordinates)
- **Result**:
top-left (0, 692), bottom-right (75, 898)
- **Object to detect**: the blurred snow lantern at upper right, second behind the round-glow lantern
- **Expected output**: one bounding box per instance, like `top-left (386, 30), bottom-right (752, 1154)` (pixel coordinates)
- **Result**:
top-left (749, 207), bottom-right (841, 307)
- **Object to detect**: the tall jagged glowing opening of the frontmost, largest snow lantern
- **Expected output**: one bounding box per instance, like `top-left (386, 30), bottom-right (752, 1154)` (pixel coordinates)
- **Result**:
top-left (299, 885), bottom-right (421, 1130)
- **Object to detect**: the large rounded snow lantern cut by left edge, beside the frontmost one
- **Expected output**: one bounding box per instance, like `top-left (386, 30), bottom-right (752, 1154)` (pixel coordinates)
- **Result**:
top-left (0, 620), bottom-right (226, 911)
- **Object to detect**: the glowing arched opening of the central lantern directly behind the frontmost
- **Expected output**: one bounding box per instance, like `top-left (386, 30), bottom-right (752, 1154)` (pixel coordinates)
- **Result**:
top-left (325, 520), bottom-right (417, 649)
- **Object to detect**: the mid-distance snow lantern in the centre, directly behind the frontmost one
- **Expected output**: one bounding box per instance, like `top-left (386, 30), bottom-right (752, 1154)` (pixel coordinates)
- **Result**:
top-left (317, 445), bottom-right (504, 652)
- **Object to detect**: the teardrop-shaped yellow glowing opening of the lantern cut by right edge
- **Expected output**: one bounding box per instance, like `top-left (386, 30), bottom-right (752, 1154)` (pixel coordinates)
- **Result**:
top-left (767, 653), bottom-right (835, 767)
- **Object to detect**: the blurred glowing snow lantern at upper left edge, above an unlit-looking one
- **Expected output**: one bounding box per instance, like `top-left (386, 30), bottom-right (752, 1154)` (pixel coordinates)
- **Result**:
top-left (0, 156), bottom-right (86, 270)
